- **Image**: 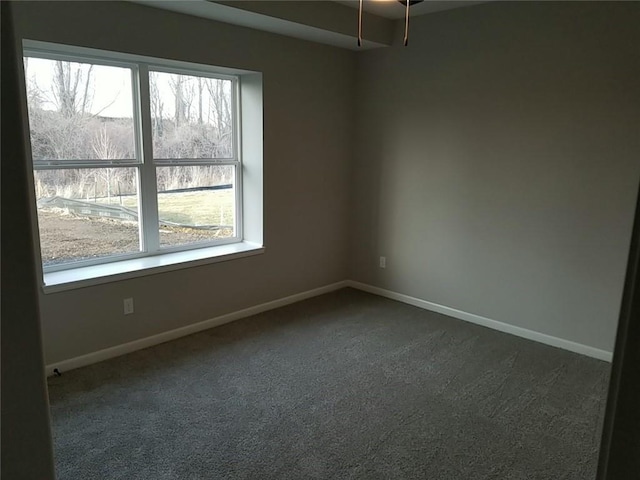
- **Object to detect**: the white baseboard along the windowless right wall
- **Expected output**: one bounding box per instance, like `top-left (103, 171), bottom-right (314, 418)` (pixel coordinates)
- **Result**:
top-left (347, 280), bottom-right (613, 362)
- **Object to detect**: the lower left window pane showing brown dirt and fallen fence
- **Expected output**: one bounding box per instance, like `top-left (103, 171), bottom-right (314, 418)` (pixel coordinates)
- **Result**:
top-left (34, 168), bottom-right (140, 266)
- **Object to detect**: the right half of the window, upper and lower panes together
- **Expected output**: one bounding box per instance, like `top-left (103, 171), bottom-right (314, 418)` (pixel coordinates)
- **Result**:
top-left (149, 70), bottom-right (240, 248)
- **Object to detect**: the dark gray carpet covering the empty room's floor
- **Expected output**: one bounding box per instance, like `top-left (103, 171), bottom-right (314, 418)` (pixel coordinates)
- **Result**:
top-left (49, 289), bottom-right (609, 480)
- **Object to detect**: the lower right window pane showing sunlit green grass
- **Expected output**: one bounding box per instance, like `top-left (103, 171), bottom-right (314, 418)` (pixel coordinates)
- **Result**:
top-left (157, 165), bottom-right (236, 247)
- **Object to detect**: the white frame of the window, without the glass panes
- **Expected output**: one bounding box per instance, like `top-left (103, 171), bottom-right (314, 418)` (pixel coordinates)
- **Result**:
top-left (23, 40), bottom-right (264, 293)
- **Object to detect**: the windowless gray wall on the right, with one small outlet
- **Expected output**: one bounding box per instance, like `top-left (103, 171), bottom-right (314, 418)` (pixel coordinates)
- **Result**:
top-left (351, 2), bottom-right (640, 351)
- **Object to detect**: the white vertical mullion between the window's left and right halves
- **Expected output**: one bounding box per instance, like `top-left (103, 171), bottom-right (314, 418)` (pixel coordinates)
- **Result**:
top-left (136, 64), bottom-right (160, 253)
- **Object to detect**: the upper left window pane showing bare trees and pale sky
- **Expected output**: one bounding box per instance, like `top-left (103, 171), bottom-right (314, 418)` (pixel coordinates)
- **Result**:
top-left (24, 57), bottom-right (135, 162)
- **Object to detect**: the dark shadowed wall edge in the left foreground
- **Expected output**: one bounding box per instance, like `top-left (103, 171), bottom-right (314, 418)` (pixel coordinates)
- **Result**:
top-left (0, 2), bottom-right (55, 480)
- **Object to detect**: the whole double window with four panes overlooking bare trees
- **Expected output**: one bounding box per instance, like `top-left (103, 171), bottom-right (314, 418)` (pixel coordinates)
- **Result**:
top-left (24, 42), bottom-right (262, 288)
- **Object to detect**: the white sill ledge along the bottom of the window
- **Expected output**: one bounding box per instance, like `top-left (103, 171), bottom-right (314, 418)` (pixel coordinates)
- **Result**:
top-left (43, 242), bottom-right (265, 294)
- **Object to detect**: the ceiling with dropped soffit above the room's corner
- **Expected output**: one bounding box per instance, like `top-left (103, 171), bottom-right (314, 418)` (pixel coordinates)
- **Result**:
top-left (134, 0), bottom-right (486, 50)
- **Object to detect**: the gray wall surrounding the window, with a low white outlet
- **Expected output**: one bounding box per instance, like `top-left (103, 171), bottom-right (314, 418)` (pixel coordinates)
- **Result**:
top-left (15, 2), bottom-right (355, 364)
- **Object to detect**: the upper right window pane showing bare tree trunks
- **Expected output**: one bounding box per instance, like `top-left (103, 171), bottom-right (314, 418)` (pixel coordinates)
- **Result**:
top-left (149, 72), bottom-right (233, 159)
